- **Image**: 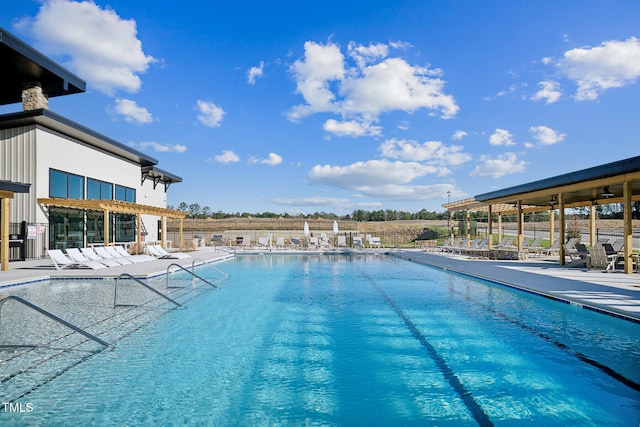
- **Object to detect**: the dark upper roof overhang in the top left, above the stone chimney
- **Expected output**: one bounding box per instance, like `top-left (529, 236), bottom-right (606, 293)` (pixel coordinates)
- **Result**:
top-left (0, 27), bottom-right (86, 105)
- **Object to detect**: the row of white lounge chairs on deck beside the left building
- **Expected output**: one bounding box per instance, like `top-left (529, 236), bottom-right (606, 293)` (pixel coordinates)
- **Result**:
top-left (47, 245), bottom-right (189, 270)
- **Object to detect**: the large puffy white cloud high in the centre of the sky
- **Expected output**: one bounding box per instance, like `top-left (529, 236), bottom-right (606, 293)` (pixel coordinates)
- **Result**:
top-left (288, 41), bottom-right (459, 136)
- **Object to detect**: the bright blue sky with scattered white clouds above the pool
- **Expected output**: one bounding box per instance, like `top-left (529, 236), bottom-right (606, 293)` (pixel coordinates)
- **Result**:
top-left (0, 0), bottom-right (640, 214)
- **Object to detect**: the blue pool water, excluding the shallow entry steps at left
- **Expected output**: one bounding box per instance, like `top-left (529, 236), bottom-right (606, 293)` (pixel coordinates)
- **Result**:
top-left (0, 255), bottom-right (640, 426)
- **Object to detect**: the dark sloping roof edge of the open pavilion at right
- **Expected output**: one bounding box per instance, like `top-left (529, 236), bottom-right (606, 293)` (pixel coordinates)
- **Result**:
top-left (475, 156), bottom-right (640, 202)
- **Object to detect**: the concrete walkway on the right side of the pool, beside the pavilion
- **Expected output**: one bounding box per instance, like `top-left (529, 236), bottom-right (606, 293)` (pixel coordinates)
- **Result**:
top-left (393, 250), bottom-right (640, 322)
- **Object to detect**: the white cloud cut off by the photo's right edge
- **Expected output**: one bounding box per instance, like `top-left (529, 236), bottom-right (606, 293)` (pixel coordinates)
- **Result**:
top-left (558, 37), bottom-right (640, 101)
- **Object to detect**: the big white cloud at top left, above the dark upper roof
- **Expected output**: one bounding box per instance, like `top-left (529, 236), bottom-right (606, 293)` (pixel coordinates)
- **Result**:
top-left (18, 0), bottom-right (155, 96)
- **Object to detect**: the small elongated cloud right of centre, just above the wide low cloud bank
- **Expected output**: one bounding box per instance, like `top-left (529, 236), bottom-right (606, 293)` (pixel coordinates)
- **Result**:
top-left (380, 139), bottom-right (471, 165)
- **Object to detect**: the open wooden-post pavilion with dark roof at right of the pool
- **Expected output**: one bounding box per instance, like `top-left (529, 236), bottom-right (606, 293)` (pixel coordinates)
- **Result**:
top-left (442, 156), bottom-right (640, 273)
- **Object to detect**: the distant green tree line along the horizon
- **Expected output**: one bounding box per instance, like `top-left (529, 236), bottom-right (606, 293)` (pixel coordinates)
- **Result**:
top-left (169, 202), bottom-right (640, 222)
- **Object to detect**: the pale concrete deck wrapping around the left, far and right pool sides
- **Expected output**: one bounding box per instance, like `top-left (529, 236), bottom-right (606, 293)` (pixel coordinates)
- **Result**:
top-left (0, 246), bottom-right (640, 322)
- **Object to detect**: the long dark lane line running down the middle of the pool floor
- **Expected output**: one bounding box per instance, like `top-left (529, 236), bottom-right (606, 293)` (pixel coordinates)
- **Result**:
top-left (362, 272), bottom-right (493, 427)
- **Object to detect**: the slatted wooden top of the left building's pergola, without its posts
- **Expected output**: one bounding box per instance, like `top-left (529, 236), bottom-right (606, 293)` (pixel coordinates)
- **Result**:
top-left (38, 197), bottom-right (188, 218)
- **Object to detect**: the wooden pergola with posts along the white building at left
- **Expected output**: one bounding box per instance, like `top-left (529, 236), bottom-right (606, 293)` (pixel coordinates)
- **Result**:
top-left (38, 197), bottom-right (188, 251)
